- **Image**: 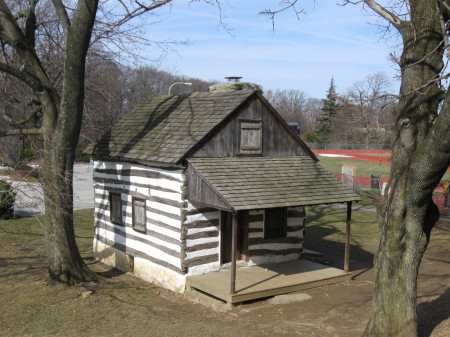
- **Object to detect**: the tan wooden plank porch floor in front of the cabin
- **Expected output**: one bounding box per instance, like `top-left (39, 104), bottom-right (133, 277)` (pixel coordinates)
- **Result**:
top-left (186, 260), bottom-right (351, 304)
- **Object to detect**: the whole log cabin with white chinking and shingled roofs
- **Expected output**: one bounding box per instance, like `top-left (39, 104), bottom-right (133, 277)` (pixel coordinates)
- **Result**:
top-left (91, 83), bottom-right (359, 303)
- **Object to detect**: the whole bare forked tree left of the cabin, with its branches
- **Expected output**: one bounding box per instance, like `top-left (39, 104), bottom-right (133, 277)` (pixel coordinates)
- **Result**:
top-left (0, 0), bottom-right (199, 284)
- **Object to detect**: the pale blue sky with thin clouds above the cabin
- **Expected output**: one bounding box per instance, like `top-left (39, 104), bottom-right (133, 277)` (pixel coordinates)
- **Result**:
top-left (140, 0), bottom-right (399, 98)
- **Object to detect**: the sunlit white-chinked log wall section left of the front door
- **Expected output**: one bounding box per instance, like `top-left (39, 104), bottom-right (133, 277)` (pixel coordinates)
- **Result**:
top-left (183, 202), bottom-right (220, 275)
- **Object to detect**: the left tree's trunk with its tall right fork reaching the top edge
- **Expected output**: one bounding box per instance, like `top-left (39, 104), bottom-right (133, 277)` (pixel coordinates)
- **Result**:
top-left (37, 0), bottom-right (98, 284)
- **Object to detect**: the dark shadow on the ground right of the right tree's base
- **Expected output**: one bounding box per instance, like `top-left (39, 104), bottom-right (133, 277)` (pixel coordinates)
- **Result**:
top-left (417, 288), bottom-right (450, 337)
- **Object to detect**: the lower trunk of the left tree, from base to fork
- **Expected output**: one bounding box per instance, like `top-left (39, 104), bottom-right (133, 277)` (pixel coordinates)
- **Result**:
top-left (41, 88), bottom-right (96, 284)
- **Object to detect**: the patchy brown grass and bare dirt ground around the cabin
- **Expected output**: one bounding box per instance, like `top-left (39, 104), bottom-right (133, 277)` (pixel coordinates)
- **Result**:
top-left (0, 210), bottom-right (450, 337)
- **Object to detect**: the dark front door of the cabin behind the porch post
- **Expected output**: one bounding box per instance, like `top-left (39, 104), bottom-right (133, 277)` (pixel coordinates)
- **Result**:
top-left (220, 211), bottom-right (248, 264)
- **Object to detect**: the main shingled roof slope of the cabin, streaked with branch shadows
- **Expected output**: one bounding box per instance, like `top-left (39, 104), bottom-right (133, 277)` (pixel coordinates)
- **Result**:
top-left (88, 90), bottom-right (256, 164)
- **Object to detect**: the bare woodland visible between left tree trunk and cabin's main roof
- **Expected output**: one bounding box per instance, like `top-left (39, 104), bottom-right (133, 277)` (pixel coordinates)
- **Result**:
top-left (79, 63), bottom-right (213, 148)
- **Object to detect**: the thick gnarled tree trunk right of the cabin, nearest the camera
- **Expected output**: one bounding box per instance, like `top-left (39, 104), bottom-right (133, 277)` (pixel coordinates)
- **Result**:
top-left (364, 1), bottom-right (450, 337)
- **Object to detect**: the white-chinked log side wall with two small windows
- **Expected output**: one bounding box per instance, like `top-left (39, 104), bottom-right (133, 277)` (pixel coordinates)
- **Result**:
top-left (94, 161), bottom-right (183, 273)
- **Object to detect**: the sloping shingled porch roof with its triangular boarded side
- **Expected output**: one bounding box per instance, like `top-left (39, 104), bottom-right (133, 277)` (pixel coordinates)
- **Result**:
top-left (188, 156), bottom-right (361, 211)
